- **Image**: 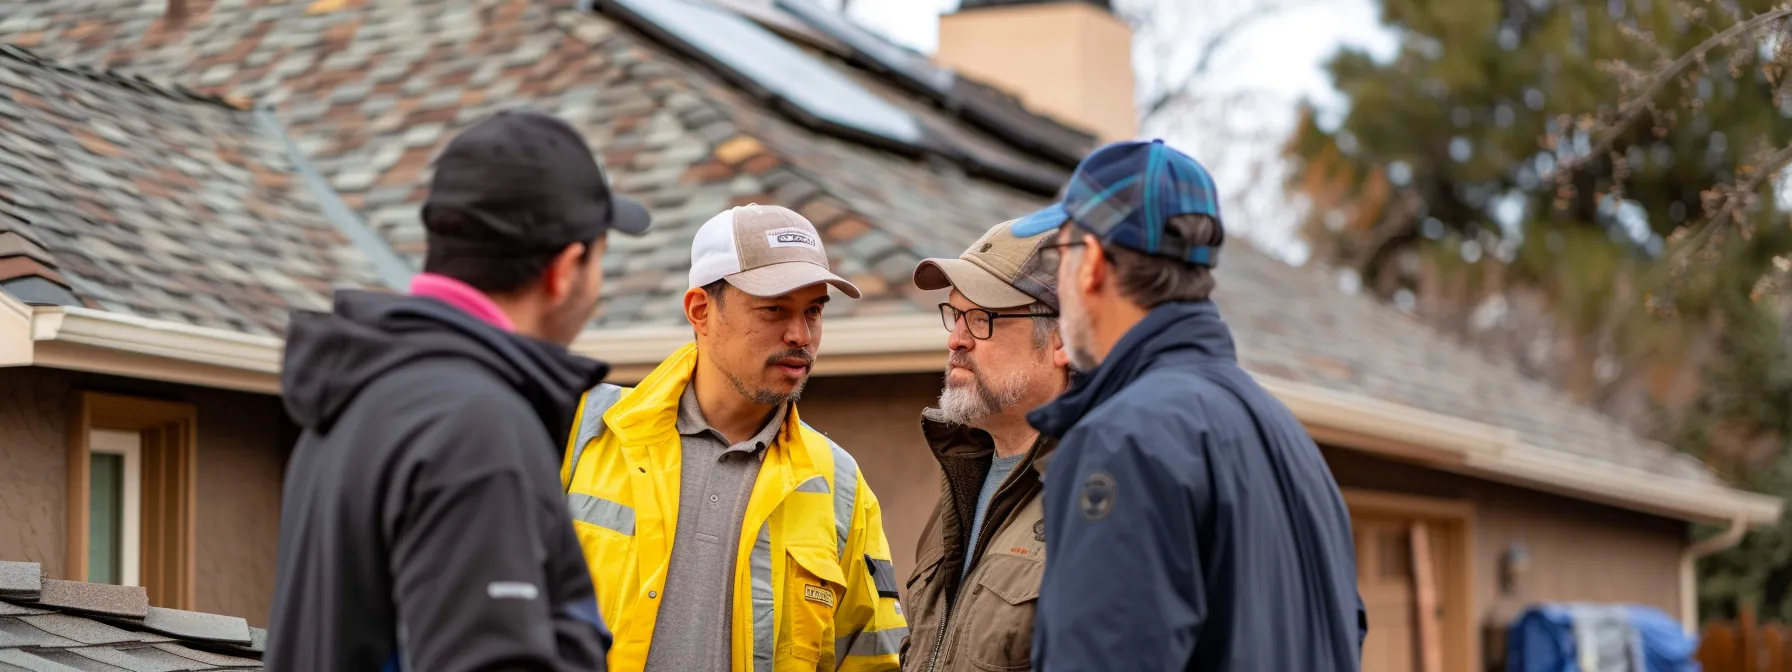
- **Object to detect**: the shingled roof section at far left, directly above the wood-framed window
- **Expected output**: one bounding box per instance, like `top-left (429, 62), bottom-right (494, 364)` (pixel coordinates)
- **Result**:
top-left (0, 42), bottom-right (381, 333)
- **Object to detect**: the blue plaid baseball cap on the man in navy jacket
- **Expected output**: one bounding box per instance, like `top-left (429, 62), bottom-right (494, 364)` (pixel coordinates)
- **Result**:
top-left (1009, 140), bottom-right (1220, 265)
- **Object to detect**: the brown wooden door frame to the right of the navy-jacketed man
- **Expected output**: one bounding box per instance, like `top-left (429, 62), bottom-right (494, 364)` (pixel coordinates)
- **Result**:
top-left (1342, 487), bottom-right (1480, 672)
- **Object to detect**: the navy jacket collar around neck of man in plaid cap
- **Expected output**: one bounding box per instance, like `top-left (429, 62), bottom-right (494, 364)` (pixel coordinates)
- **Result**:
top-left (1027, 301), bottom-right (1238, 439)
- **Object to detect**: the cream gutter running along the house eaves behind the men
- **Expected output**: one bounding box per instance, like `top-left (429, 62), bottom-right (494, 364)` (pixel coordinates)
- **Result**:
top-left (0, 308), bottom-right (1783, 525)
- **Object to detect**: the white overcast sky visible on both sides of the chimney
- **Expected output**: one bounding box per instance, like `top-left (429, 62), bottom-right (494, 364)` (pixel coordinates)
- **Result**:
top-left (823, 0), bottom-right (1396, 262)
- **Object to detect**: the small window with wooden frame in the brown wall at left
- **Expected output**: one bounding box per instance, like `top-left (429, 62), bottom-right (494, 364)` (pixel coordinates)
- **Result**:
top-left (65, 392), bottom-right (199, 609)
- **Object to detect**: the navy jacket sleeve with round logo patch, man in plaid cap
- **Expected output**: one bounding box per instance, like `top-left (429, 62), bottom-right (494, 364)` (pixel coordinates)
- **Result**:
top-left (1034, 426), bottom-right (1206, 672)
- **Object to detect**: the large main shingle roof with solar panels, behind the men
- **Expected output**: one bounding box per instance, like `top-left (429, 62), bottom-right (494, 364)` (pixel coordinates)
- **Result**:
top-left (0, 0), bottom-right (1715, 482)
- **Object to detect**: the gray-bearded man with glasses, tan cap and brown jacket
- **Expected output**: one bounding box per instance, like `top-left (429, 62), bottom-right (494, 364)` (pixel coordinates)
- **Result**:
top-left (901, 224), bottom-right (1070, 672)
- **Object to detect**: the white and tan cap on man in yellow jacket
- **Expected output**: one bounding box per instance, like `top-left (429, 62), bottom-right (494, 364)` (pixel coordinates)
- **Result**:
top-left (690, 202), bottom-right (858, 299)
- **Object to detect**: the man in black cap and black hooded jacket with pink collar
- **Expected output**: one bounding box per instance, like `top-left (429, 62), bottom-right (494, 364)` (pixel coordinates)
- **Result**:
top-left (265, 111), bottom-right (649, 672)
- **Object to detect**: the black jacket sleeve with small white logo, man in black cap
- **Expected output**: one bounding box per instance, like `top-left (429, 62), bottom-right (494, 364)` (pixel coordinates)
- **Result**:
top-left (389, 400), bottom-right (607, 672)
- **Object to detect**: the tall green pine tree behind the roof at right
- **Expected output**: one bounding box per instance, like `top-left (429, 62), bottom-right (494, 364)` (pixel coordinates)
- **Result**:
top-left (1287, 0), bottom-right (1792, 618)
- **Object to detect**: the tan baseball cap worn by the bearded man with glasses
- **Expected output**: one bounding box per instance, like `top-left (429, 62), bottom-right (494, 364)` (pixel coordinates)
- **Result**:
top-left (914, 220), bottom-right (1057, 312)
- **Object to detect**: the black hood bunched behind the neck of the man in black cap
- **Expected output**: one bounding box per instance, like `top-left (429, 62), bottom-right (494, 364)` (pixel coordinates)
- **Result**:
top-left (280, 290), bottom-right (609, 437)
